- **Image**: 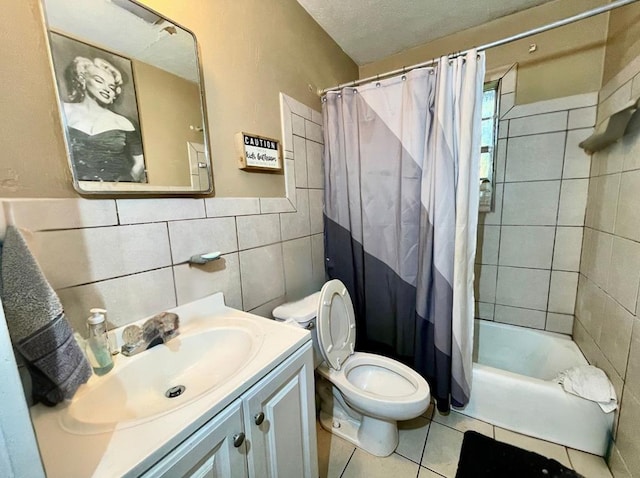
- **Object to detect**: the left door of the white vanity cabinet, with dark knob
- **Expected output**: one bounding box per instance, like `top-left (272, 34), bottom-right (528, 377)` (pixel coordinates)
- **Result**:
top-left (142, 399), bottom-right (248, 478)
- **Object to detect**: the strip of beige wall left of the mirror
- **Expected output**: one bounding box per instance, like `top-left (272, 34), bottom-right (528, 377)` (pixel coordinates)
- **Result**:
top-left (0, 0), bottom-right (76, 197)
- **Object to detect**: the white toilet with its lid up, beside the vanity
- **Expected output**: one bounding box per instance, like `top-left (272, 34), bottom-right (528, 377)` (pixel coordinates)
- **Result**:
top-left (273, 279), bottom-right (431, 456)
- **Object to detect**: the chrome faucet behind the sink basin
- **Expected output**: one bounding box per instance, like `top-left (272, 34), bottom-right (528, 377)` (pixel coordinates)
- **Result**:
top-left (120, 312), bottom-right (180, 357)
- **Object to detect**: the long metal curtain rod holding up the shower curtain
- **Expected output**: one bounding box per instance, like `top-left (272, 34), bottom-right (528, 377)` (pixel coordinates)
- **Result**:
top-left (318, 0), bottom-right (638, 95)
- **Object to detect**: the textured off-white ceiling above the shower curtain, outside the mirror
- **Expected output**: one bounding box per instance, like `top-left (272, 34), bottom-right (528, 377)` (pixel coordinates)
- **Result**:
top-left (298, 0), bottom-right (550, 65)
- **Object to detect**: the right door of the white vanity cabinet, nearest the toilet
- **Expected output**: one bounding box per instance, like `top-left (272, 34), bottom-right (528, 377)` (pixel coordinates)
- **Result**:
top-left (243, 342), bottom-right (318, 478)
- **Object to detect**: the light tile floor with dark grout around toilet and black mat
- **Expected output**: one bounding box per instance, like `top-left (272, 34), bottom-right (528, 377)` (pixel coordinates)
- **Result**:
top-left (317, 406), bottom-right (611, 478)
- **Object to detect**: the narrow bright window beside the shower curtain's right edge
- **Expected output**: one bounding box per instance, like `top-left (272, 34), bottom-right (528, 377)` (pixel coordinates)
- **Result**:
top-left (480, 80), bottom-right (500, 212)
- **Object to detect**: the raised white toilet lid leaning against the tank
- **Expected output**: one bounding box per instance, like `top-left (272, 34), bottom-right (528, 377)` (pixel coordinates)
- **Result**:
top-left (316, 279), bottom-right (356, 370)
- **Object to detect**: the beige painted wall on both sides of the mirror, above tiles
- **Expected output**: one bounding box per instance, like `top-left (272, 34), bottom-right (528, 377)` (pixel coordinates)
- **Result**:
top-left (0, 0), bottom-right (357, 197)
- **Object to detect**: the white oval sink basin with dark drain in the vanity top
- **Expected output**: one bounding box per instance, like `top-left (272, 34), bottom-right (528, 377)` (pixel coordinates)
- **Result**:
top-left (61, 317), bottom-right (263, 434)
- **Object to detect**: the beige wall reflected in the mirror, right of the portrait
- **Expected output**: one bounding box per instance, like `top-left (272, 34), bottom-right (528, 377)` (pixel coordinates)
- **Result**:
top-left (133, 61), bottom-right (204, 186)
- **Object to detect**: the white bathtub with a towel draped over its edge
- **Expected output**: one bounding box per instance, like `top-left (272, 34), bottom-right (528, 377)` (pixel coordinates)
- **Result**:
top-left (458, 320), bottom-right (614, 456)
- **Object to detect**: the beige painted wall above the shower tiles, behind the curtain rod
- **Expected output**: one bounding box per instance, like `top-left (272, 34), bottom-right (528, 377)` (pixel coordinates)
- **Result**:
top-left (360, 0), bottom-right (608, 104)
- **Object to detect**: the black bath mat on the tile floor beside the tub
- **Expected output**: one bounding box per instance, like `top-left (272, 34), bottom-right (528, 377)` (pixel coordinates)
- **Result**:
top-left (456, 431), bottom-right (582, 478)
